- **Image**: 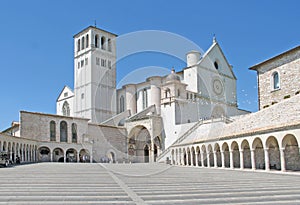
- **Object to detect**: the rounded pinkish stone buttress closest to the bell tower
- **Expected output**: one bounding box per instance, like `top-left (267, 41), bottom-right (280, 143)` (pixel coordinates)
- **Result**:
top-left (124, 84), bottom-right (137, 115)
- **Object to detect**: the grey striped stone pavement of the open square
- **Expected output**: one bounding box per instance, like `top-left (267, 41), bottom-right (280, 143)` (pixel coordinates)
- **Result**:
top-left (0, 163), bottom-right (300, 204)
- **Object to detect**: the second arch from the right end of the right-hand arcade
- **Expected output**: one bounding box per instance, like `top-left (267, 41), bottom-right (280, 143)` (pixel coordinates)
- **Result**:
top-left (265, 136), bottom-right (281, 170)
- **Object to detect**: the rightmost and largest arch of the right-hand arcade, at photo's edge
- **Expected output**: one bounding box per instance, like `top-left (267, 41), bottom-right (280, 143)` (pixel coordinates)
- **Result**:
top-left (282, 134), bottom-right (300, 170)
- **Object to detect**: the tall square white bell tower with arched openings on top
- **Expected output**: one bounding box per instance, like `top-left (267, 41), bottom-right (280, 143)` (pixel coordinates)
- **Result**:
top-left (74, 26), bottom-right (117, 123)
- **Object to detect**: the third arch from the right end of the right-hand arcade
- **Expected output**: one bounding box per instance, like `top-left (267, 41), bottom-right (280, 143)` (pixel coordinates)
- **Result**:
top-left (252, 137), bottom-right (265, 169)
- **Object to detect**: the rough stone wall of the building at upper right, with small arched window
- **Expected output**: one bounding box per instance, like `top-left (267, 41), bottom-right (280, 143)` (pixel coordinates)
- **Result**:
top-left (250, 46), bottom-right (300, 109)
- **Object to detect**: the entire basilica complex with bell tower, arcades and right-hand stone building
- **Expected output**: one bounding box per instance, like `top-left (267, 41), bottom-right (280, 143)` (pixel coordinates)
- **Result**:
top-left (0, 26), bottom-right (300, 171)
